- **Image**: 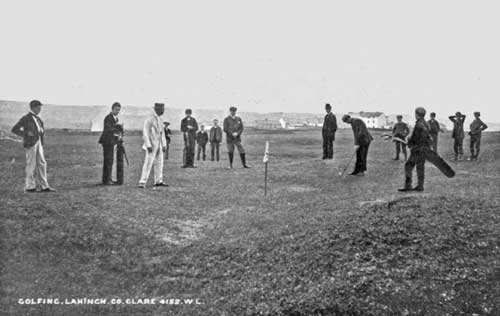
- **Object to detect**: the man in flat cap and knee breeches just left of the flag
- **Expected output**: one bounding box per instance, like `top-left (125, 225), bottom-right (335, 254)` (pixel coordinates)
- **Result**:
top-left (223, 106), bottom-right (250, 168)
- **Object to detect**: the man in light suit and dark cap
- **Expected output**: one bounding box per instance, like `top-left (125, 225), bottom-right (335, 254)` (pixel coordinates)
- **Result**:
top-left (139, 103), bottom-right (168, 188)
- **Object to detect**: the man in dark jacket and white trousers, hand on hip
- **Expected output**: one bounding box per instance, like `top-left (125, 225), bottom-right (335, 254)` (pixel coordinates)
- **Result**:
top-left (12, 100), bottom-right (55, 193)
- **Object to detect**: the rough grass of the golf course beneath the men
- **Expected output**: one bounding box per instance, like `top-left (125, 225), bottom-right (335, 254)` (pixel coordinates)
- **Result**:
top-left (0, 130), bottom-right (500, 315)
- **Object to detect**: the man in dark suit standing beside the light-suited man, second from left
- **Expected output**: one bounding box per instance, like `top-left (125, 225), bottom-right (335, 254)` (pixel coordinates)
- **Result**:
top-left (99, 102), bottom-right (121, 185)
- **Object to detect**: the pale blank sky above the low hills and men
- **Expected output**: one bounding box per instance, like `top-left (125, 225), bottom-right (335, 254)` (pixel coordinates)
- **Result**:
top-left (0, 0), bottom-right (500, 122)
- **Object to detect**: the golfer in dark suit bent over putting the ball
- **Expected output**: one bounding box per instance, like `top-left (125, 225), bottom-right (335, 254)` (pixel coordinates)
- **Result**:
top-left (342, 114), bottom-right (373, 176)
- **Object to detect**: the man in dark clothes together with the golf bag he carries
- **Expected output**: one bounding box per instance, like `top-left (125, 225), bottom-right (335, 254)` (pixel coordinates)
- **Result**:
top-left (399, 107), bottom-right (455, 192)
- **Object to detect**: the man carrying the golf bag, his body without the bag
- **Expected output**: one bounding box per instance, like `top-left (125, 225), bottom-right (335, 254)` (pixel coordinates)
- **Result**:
top-left (399, 107), bottom-right (432, 192)
